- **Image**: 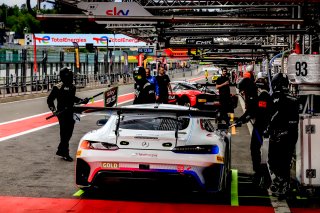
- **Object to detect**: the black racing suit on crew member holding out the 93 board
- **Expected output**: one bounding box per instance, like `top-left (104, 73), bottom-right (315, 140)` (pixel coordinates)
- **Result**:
top-left (47, 82), bottom-right (83, 157)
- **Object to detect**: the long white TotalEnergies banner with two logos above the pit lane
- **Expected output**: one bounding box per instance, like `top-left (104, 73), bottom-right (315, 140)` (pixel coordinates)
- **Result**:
top-left (25, 34), bottom-right (147, 47)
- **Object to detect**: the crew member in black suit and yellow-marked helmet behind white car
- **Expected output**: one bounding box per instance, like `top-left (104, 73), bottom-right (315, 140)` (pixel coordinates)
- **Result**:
top-left (133, 67), bottom-right (156, 104)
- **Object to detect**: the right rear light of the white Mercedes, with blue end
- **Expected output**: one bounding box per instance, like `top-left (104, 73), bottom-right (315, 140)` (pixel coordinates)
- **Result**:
top-left (172, 145), bottom-right (219, 154)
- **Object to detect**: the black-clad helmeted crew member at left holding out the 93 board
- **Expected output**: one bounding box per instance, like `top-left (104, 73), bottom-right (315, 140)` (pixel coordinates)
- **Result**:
top-left (47, 67), bottom-right (89, 162)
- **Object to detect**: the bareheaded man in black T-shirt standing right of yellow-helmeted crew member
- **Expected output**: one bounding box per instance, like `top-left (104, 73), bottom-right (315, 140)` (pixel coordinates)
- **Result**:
top-left (156, 67), bottom-right (172, 104)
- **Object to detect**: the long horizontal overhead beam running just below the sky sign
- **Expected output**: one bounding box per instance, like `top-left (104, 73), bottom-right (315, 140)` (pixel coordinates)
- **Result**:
top-left (37, 14), bottom-right (304, 25)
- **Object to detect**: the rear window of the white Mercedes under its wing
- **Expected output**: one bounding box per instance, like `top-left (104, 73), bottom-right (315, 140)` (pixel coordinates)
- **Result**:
top-left (119, 116), bottom-right (190, 131)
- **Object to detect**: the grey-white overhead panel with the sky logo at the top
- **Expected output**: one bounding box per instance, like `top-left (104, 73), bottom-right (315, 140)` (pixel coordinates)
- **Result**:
top-left (77, 2), bottom-right (152, 16)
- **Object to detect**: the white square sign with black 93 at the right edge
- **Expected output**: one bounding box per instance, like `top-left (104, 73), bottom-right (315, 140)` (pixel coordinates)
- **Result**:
top-left (288, 54), bottom-right (320, 84)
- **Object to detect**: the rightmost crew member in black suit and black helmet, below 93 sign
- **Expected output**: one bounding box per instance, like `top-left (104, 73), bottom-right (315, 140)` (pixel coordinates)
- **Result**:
top-left (265, 73), bottom-right (299, 197)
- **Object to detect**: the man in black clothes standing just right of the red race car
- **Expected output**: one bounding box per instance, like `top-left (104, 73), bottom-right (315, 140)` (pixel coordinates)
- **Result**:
top-left (216, 67), bottom-right (233, 125)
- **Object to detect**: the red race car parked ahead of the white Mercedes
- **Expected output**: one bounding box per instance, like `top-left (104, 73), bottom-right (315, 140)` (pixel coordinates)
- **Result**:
top-left (168, 81), bottom-right (238, 110)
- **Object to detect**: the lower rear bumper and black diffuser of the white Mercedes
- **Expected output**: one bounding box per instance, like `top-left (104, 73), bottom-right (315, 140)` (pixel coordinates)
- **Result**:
top-left (76, 158), bottom-right (224, 192)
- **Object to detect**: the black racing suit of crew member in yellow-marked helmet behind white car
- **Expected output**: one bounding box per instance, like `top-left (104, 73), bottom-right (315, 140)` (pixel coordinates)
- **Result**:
top-left (133, 79), bottom-right (156, 104)
